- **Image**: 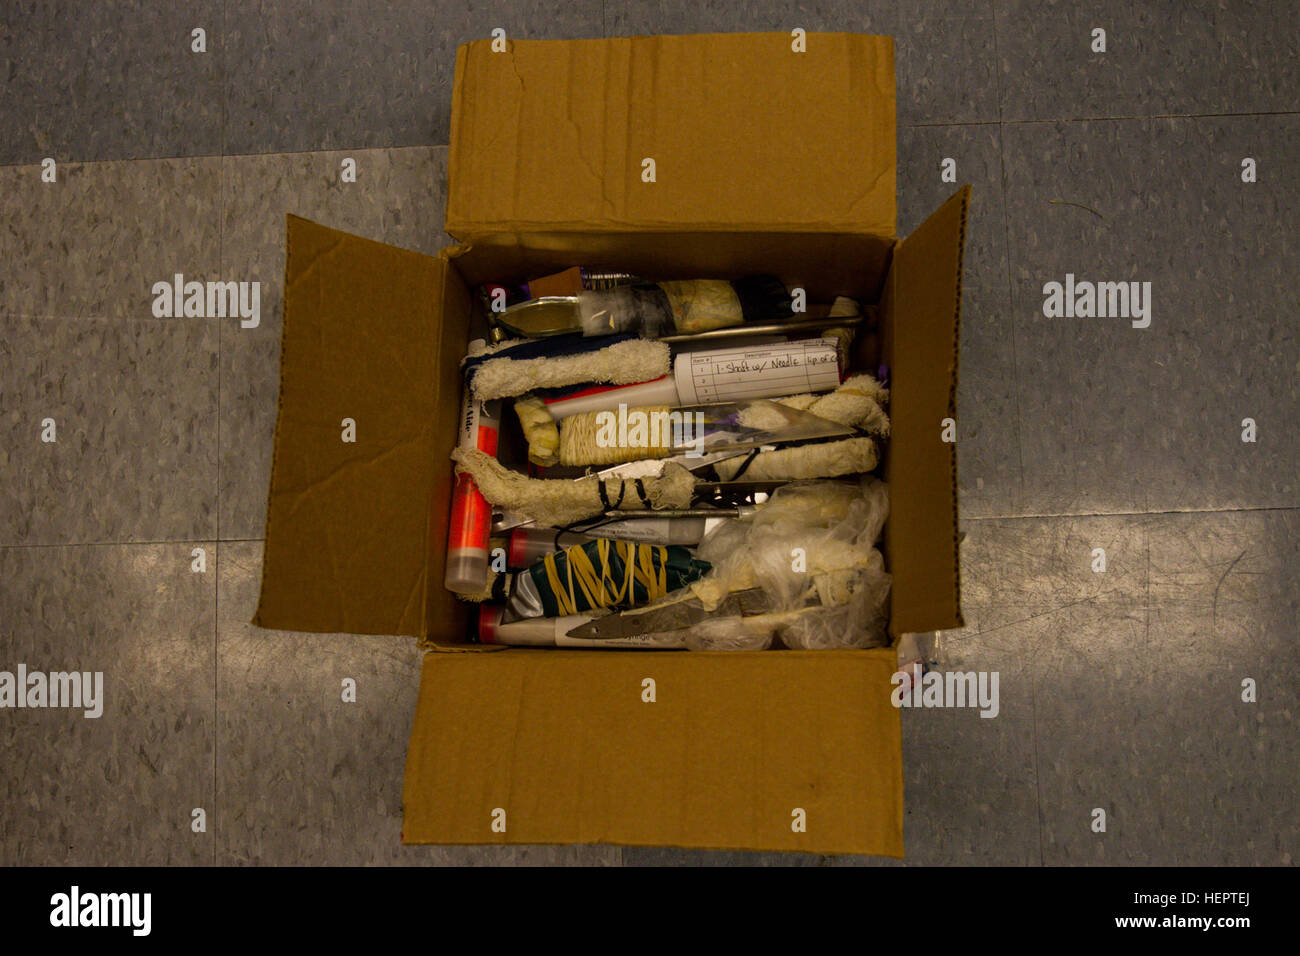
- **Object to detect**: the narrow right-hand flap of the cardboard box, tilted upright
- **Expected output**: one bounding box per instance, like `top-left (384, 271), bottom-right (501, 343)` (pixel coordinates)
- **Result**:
top-left (881, 186), bottom-right (970, 635)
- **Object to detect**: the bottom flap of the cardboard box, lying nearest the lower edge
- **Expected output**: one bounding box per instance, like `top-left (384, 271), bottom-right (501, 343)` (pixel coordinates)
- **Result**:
top-left (403, 648), bottom-right (902, 856)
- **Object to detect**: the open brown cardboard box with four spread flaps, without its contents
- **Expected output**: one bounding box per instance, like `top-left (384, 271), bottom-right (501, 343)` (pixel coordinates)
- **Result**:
top-left (255, 34), bottom-right (969, 856)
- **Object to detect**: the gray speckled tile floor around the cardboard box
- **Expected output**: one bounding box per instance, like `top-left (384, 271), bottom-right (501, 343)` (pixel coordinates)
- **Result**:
top-left (0, 0), bottom-right (1300, 865)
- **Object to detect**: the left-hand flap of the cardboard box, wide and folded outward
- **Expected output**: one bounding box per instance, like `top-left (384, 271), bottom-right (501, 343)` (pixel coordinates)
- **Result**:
top-left (254, 216), bottom-right (452, 635)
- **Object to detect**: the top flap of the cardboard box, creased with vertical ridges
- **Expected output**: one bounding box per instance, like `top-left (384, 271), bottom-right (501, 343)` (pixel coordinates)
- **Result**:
top-left (446, 33), bottom-right (896, 241)
